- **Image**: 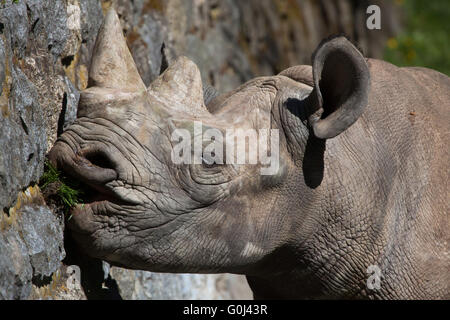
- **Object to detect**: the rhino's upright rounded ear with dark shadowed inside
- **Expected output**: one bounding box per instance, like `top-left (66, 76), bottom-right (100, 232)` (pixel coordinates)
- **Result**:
top-left (308, 37), bottom-right (370, 139)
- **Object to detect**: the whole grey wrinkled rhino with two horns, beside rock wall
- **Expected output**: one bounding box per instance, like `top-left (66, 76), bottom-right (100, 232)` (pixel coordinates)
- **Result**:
top-left (49, 11), bottom-right (450, 299)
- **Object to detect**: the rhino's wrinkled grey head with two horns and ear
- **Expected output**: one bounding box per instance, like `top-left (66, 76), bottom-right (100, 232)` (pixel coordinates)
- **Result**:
top-left (49, 10), bottom-right (369, 274)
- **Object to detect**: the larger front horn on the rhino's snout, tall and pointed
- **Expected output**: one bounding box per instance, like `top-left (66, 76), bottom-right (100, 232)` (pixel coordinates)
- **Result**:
top-left (89, 8), bottom-right (146, 91)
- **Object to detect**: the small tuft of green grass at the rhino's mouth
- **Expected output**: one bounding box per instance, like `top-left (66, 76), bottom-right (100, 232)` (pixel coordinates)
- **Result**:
top-left (39, 161), bottom-right (83, 219)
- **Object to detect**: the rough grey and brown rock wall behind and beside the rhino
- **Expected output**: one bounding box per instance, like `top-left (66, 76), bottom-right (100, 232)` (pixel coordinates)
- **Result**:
top-left (0, 0), bottom-right (398, 299)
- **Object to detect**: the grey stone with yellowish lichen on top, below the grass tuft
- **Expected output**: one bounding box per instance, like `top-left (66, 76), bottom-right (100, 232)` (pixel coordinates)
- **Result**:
top-left (0, 186), bottom-right (65, 299)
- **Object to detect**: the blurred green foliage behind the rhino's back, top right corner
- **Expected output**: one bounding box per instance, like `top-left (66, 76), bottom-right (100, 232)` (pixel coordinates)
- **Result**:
top-left (384, 0), bottom-right (450, 75)
